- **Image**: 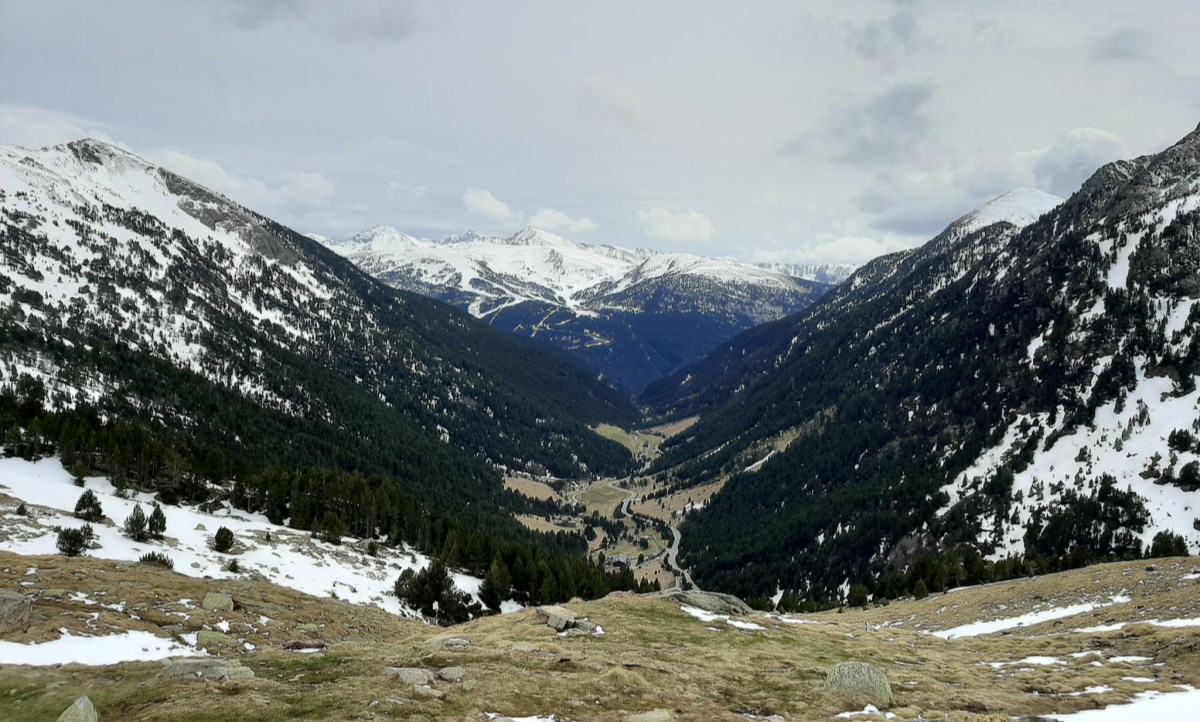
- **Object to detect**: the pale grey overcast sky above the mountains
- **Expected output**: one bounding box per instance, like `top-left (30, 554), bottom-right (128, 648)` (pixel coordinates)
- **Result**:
top-left (0, 0), bottom-right (1200, 261)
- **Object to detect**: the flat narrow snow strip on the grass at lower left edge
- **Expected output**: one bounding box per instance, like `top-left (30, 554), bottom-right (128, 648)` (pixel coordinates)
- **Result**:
top-left (0, 630), bottom-right (206, 666)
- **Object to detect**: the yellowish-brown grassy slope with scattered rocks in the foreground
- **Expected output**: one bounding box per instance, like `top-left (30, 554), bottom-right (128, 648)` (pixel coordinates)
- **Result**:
top-left (0, 553), bottom-right (1200, 722)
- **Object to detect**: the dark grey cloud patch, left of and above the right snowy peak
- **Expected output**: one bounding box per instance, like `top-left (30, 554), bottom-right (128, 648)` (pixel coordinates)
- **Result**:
top-left (784, 82), bottom-right (936, 166)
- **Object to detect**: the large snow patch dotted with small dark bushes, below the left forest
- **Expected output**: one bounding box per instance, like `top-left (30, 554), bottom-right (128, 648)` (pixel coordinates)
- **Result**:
top-left (0, 458), bottom-right (487, 618)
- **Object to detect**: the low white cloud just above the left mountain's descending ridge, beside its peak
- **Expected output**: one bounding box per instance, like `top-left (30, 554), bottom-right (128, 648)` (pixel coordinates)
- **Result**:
top-left (152, 150), bottom-right (337, 210)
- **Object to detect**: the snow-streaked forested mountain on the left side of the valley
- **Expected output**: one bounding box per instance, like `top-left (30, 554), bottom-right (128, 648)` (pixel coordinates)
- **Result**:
top-left (0, 140), bottom-right (634, 549)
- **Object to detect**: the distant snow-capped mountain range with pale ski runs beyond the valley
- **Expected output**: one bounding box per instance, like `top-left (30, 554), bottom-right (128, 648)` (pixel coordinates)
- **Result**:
top-left (319, 225), bottom-right (827, 391)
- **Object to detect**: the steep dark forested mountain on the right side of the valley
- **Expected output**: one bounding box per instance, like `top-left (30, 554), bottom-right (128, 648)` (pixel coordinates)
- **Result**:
top-left (642, 133), bottom-right (1200, 598)
